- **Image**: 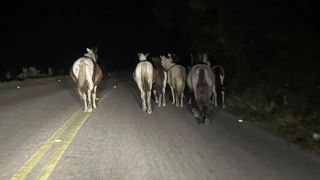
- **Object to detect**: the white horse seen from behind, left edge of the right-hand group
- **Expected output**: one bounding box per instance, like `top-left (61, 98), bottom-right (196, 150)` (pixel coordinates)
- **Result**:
top-left (133, 53), bottom-right (153, 114)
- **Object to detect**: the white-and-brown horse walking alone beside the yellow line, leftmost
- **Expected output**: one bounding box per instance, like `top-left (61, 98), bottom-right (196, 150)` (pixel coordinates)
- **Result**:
top-left (69, 48), bottom-right (103, 112)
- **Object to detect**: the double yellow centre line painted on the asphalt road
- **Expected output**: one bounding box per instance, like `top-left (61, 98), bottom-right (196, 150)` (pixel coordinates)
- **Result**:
top-left (11, 89), bottom-right (114, 180)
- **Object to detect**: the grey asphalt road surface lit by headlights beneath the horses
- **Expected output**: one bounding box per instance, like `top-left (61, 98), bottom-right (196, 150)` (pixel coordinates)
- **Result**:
top-left (0, 73), bottom-right (320, 180)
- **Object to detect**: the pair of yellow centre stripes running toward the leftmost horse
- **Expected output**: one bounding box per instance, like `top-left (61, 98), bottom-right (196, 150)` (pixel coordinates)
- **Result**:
top-left (11, 86), bottom-right (114, 180)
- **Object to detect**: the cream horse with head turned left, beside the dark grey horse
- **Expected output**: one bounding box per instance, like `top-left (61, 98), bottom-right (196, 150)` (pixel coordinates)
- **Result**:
top-left (160, 54), bottom-right (187, 107)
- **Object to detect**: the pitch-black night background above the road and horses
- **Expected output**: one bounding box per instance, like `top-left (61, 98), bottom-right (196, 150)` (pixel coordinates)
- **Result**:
top-left (1, 0), bottom-right (320, 89)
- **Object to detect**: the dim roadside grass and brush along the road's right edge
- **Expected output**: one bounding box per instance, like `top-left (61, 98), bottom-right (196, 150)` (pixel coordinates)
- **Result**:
top-left (226, 88), bottom-right (320, 155)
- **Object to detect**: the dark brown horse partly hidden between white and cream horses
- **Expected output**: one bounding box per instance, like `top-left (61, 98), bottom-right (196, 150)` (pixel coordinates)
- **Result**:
top-left (152, 57), bottom-right (167, 107)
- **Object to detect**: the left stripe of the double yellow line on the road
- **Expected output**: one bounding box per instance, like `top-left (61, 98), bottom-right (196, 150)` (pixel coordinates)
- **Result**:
top-left (11, 108), bottom-right (81, 180)
